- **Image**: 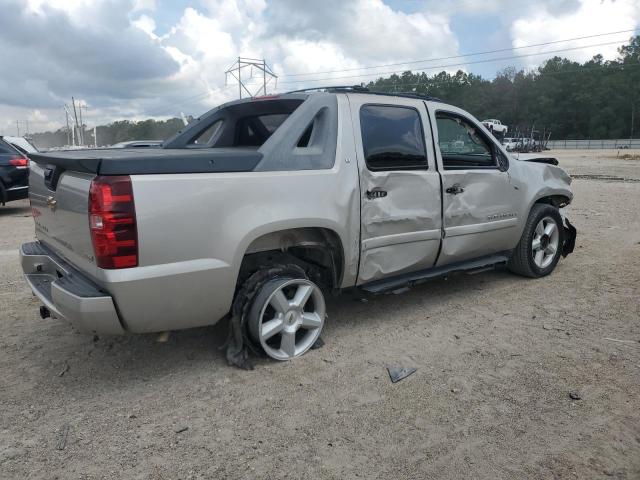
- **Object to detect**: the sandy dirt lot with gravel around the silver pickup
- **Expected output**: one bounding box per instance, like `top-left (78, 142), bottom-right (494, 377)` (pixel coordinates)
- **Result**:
top-left (0, 151), bottom-right (640, 480)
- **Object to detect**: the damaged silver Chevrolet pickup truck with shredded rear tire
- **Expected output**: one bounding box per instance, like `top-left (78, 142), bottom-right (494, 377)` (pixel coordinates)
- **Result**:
top-left (21, 88), bottom-right (575, 366)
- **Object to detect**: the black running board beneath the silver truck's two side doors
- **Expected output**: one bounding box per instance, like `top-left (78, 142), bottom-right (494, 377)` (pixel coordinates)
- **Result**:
top-left (359, 252), bottom-right (509, 293)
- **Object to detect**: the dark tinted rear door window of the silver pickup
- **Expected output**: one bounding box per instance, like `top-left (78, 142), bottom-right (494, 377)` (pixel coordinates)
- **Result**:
top-left (360, 105), bottom-right (427, 170)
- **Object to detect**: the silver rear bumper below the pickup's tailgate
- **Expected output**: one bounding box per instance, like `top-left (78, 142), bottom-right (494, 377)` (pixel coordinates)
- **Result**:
top-left (20, 242), bottom-right (126, 335)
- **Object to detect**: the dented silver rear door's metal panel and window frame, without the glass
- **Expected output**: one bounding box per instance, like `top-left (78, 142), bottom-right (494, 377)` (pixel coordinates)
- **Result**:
top-left (349, 95), bottom-right (442, 284)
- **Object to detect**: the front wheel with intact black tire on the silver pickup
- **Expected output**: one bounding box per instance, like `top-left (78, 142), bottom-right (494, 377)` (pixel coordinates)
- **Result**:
top-left (508, 203), bottom-right (564, 278)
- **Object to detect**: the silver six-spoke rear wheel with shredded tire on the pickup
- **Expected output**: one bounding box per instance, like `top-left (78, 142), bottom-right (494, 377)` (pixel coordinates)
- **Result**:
top-left (247, 275), bottom-right (326, 361)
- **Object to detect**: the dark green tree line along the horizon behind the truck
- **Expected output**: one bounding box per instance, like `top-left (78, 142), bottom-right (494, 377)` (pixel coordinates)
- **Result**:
top-left (33, 35), bottom-right (640, 147)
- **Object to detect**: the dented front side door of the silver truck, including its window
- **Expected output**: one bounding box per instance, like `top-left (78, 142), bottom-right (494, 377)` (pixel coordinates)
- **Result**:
top-left (429, 103), bottom-right (522, 266)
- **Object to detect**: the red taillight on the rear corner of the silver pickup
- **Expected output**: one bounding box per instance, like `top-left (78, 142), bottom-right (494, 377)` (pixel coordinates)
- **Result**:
top-left (89, 175), bottom-right (138, 269)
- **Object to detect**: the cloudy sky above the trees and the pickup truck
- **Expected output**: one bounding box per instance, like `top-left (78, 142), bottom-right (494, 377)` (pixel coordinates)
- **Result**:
top-left (0, 0), bottom-right (640, 135)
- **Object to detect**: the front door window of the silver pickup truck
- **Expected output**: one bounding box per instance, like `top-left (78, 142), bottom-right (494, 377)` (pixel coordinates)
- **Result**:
top-left (436, 112), bottom-right (497, 169)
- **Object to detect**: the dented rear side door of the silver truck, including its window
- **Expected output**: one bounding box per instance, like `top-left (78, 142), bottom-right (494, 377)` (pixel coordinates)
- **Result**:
top-left (349, 94), bottom-right (442, 284)
